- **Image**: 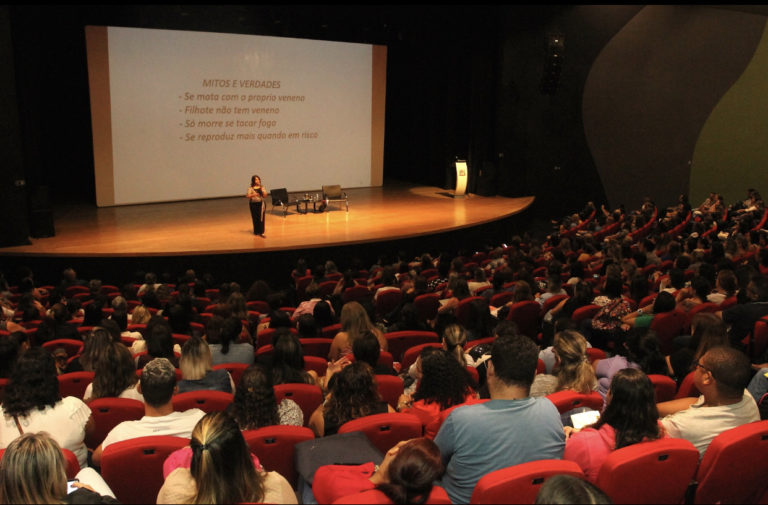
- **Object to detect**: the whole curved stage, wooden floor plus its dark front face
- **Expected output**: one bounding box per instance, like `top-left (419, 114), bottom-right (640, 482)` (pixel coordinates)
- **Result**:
top-left (0, 182), bottom-right (534, 289)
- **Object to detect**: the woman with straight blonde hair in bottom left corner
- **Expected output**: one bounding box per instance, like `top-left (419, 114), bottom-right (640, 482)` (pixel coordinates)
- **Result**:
top-left (0, 432), bottom-right (119, 504)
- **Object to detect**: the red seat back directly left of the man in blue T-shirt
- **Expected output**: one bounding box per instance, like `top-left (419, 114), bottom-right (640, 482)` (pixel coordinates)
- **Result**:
top-left (339, 412), bottom-right (423, 454)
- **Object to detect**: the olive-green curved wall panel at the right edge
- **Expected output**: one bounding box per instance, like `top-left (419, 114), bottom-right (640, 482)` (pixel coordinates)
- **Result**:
top-left (690, 20), bottom-right (768, 203)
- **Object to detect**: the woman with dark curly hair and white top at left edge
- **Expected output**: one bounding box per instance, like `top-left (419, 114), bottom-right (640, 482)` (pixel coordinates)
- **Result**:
top-left (0, 347), bottom-right (94, 468)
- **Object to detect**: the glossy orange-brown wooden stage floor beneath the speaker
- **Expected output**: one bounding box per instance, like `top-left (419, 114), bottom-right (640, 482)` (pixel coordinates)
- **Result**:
top-left (0, 183), bottom-right (534, 257)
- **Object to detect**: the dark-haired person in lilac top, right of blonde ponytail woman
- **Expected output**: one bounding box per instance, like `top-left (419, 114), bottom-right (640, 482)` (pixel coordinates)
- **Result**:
top-left (592, 328), bottom-right (667, 397)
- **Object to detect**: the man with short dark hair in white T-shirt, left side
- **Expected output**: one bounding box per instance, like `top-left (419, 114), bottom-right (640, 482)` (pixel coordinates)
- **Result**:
top-left (92, 358), bottom-right (205, 466)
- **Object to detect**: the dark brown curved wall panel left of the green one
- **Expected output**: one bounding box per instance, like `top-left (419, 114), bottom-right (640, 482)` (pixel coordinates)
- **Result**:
top-left (582, 5), bottom-right (765, 208)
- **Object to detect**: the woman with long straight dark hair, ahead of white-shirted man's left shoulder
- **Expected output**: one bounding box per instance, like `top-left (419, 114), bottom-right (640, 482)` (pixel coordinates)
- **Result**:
top-left (83, 342), bottom-right (144, 402)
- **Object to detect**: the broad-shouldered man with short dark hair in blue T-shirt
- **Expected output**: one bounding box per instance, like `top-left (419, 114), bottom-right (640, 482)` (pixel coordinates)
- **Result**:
top-left (435, 334), bottom-right (565, 503)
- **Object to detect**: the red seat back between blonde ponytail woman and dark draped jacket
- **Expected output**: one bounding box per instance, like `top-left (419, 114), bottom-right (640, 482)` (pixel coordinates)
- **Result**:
top-left (243, 426), bottom-right (315, 488)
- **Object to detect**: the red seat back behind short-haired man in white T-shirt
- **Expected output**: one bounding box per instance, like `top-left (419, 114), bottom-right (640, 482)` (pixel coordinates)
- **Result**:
top-left (101, 436), bottom-right (189, 503)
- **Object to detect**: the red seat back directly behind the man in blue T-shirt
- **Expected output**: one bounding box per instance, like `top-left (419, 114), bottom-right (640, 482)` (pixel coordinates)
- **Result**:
top-left (469, 459), bottom-right (584, 504)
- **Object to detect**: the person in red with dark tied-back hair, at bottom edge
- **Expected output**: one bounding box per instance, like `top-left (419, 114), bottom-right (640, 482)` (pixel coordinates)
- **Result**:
top-left (312, 438), bottom-right (445, 504)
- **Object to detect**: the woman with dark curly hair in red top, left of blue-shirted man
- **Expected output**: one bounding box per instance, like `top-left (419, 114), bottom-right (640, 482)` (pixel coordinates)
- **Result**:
top-left (397, 347), bottom-right (478, 432)
